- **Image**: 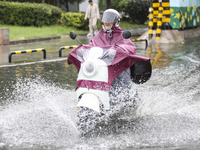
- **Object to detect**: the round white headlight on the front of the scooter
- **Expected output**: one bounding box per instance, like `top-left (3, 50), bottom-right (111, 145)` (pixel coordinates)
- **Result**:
top-left (83, 61), bottom-right (96, 76)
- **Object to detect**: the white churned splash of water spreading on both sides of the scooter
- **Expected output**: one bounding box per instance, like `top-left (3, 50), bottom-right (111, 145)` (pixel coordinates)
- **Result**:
top-left (0, 49), bottom-right (200, 149)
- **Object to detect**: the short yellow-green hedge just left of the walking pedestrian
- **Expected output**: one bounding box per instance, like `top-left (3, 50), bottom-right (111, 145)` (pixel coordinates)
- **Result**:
top-left (61, 12), bottom-right (88, 29)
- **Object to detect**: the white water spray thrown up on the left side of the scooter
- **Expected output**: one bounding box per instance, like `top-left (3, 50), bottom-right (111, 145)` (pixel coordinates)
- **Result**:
top-left (0, 78), bottom-right (78, 147)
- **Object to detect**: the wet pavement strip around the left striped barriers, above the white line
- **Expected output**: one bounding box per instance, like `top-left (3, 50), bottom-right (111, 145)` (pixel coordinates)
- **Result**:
top-left (0, 36), bottom-right (90, 65)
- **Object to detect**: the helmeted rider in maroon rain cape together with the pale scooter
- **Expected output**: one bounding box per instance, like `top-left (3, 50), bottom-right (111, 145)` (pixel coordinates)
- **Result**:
top-left (67, 9), bottom-right (151, 135)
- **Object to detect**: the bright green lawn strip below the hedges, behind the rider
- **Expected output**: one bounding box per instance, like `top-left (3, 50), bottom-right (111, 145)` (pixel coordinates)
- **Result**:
top-left (0, 21), bottom-right (147, 40)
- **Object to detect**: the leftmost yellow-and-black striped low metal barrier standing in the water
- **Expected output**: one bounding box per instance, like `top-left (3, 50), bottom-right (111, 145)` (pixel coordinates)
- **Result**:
top-left (8, 48), bottom-right (46, 63)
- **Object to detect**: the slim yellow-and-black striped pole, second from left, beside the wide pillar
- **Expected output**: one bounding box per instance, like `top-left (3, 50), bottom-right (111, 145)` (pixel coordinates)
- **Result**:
top-left (156, 0), bottom-right (163, 40)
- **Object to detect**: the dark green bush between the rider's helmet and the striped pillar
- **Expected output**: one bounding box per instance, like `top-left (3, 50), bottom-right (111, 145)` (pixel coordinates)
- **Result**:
top-left (125, 0), bottom-right (149, 24)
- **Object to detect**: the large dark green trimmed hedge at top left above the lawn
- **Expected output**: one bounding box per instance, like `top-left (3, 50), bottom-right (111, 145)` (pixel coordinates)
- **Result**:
top-left (0, 2), bottom-right (62, 26)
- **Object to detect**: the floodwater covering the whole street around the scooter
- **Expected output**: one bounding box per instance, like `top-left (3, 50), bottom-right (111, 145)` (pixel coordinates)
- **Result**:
top-left (0, 35), bottom-right (200, 150)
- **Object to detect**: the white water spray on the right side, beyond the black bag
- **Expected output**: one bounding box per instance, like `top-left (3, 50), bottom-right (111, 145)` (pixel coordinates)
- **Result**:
top-left (129, 62), bottom-right (200, 147)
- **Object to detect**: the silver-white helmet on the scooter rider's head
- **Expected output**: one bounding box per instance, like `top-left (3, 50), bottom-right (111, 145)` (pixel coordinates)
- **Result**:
top-left (101, 9), bottom-right (120, 32)
